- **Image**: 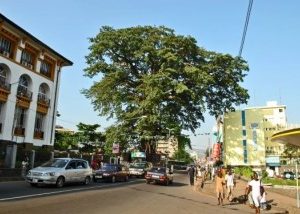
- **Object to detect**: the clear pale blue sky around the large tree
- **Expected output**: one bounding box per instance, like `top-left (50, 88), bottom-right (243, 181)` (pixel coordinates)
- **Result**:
top-left (0, 0), bottom-right (300, 149)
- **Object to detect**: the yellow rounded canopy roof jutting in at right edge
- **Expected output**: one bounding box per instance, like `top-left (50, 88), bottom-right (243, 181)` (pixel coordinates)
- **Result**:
top-left (271, 128), bottom-right (300, 147)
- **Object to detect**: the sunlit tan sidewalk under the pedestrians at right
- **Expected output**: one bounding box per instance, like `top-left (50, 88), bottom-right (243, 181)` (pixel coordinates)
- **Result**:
top-left (194, 179), bottom-right (300, 214)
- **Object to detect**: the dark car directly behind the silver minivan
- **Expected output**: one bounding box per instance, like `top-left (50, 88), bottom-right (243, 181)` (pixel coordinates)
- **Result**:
top-left (93, 164), bottom-right (129, 183)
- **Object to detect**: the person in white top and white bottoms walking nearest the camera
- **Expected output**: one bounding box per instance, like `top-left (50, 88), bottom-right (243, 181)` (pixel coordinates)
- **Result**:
top-left (246, 172), bottom-right (262, 214)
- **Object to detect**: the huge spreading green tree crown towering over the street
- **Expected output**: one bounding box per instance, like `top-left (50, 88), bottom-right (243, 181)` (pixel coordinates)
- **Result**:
top-left (83, 26), bottom-right (249, 152)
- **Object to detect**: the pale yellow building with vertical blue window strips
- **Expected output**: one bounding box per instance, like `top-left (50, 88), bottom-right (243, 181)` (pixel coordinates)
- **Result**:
top-left (223, 102), bottom-right (286, 167)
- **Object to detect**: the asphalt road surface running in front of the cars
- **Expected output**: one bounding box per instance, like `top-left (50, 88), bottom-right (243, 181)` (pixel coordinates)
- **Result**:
top-left (0, 174), bottom-right (253, 214)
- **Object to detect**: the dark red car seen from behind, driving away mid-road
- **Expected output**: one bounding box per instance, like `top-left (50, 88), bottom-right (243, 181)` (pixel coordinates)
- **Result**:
top-left (145, 167), bottom-right (173, 186)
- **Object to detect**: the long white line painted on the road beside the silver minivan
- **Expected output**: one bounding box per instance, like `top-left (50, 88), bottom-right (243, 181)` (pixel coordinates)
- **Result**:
top-left (0, 180), bottom-right (140, 201)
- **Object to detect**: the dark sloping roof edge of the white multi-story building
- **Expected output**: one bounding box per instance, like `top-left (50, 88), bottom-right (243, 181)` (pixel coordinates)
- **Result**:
top-left (0, 13), bottom-right (73, 66)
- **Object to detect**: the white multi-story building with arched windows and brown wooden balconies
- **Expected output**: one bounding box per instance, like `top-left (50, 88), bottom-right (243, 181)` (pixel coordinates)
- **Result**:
top-left (0, 14), bottom-right (73, 167)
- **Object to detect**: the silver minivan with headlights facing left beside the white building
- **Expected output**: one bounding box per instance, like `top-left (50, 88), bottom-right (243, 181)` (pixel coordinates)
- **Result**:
top-left (25, 158), bottom-right (93, 187)
